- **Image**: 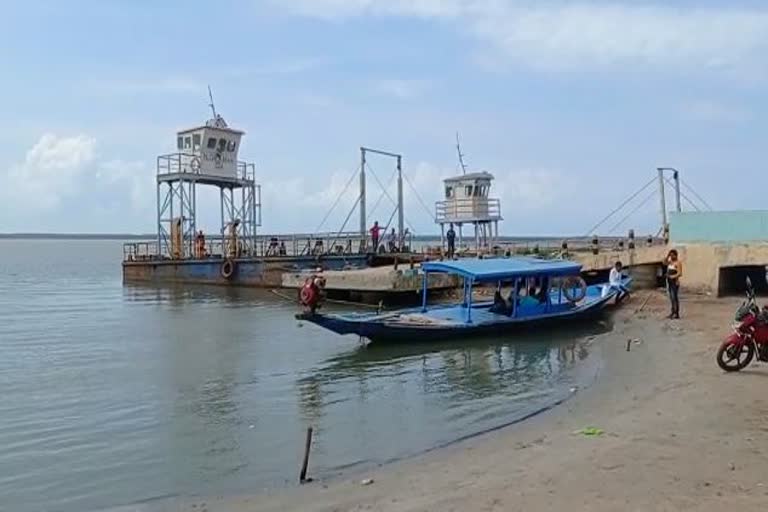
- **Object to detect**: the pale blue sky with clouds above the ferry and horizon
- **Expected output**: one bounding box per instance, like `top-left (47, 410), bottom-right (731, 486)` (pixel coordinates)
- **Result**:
top-left (0, 0), bottom-right (768, 236)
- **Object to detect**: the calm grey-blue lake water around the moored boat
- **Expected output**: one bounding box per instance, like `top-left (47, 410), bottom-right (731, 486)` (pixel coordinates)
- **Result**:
top-left (0, 240), bottom-right (605, 512)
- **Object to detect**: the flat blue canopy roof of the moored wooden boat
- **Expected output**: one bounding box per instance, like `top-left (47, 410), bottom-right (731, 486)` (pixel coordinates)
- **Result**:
top-left (421, 257), bottom-right (581, 281)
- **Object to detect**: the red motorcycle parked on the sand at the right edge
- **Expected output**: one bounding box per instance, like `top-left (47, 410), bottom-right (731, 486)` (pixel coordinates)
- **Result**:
top-left (717, 277), bottom-right (768, 372)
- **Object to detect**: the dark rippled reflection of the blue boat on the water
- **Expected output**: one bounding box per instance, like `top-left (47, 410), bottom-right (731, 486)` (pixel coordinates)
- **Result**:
top-left (296, 322), bottom-right (611, 432)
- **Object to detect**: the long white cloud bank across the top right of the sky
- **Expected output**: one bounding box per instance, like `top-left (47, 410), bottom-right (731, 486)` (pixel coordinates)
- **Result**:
top-left (280, 0), bottom-right (768, 78)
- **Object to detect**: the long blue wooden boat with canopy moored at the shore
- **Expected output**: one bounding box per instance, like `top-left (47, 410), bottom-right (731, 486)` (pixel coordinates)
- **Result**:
top-left (297, 257), bottom-right (631, 342)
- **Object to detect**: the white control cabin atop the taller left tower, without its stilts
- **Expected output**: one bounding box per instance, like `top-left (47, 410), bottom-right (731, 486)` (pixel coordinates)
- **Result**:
top-left (176, 115), bottom-right (244, 179)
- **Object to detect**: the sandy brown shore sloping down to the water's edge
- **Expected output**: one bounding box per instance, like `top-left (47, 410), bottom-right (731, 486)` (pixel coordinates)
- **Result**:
top-left (182, 292), bottom-right (768, 512)
